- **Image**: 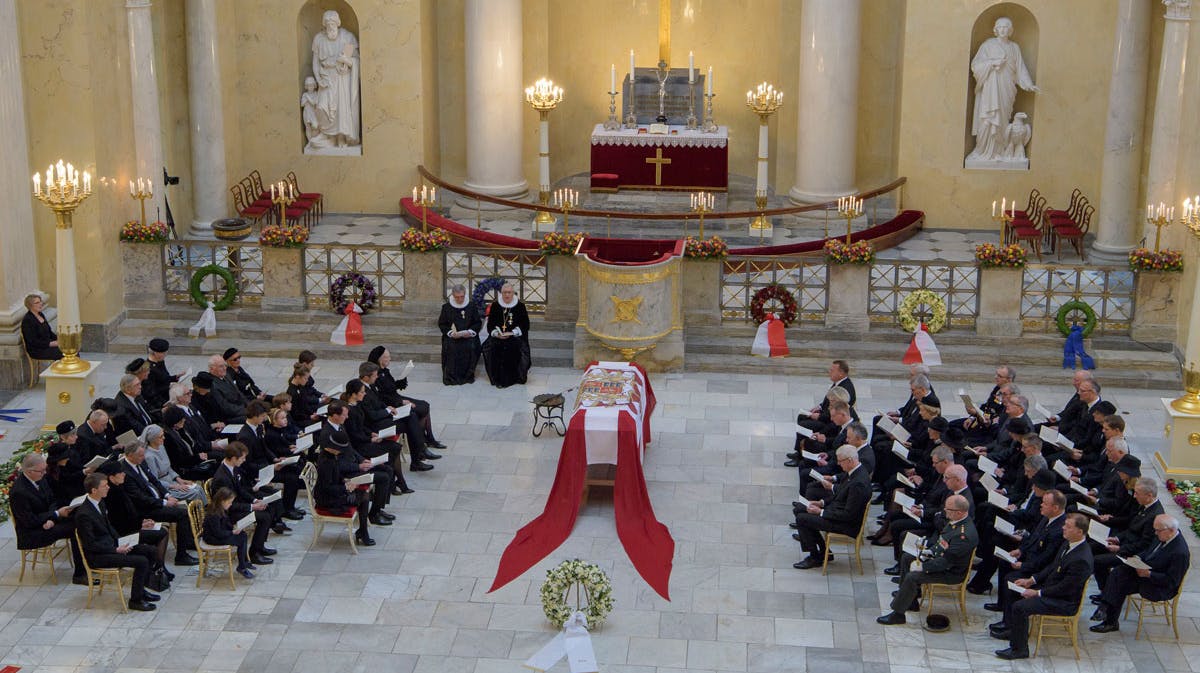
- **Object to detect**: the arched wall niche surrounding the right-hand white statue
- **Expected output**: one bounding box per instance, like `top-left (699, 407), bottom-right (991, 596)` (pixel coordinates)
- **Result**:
top-left (962, 2), bottom-right (1039, 170)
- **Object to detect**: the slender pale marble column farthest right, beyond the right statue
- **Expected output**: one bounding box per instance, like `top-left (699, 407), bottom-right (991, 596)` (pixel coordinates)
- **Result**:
top-left (1142, 0), bottom-right (1192, 248)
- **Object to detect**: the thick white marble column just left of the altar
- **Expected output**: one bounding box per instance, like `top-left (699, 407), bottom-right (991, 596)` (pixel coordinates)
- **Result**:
top-left (463, 0), bottom-right (529, 208)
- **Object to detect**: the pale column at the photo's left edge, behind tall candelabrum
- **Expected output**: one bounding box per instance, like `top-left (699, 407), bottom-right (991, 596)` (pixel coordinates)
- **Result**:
top-left (0, 0), bottom-right (49, 389)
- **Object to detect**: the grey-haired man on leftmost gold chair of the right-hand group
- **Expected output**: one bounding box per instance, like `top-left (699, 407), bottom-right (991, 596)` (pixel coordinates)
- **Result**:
top-left (792, 444), bottom-right (871, 570)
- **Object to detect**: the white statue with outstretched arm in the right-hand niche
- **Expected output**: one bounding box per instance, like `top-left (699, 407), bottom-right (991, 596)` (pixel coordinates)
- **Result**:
top-left (964, 17), bottom-right (1038, 169)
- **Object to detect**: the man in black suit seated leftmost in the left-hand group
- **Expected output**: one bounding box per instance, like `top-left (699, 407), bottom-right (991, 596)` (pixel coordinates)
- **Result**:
top-left (8, 451), bottom-right (88, 584)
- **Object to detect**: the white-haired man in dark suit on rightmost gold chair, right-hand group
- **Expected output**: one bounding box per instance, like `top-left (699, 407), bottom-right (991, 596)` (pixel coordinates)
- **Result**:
top-left (1091, 515), bottom-right (1192, 633)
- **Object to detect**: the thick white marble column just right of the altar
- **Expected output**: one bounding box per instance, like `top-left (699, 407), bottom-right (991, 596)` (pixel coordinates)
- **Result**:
top-left (788, 0), bottom-right (860, 203)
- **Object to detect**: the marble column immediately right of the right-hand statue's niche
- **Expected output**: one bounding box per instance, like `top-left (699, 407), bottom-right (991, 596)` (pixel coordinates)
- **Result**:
top-left (1092, 0), bottom-right (1151, 262)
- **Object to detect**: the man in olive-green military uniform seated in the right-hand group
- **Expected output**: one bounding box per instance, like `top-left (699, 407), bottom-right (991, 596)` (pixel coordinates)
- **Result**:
top-left (876, 487), bottom-right (979, 626)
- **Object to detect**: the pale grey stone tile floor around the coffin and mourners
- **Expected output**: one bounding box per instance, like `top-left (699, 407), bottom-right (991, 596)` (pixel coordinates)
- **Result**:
top-left (0, 355), bottom-right (1200, 673)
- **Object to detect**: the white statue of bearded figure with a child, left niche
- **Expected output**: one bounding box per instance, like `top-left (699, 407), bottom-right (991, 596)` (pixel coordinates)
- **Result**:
top-left (300, 10), bottom-right (362, 155)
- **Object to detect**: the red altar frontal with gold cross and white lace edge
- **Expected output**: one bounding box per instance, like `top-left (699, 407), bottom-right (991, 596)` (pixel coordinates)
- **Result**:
top-left (592, 124), bottom-right (730, 191)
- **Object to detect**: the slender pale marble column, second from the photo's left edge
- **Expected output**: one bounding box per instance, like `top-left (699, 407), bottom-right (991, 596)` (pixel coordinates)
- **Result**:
top-left (125, 0), bottom-right (167, 221)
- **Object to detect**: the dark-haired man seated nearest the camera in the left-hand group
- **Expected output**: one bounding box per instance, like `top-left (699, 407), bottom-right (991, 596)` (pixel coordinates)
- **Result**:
top-left (72, 474), bottom-right (160, 612)
